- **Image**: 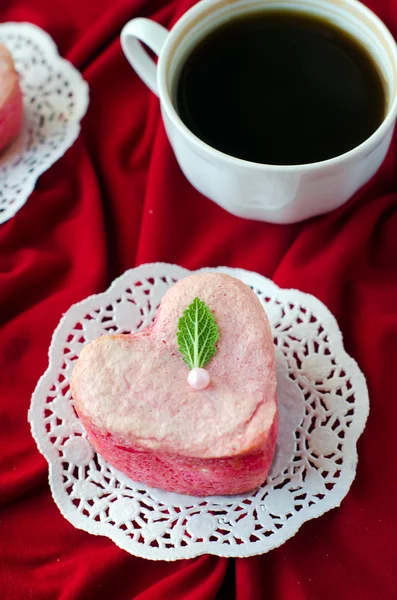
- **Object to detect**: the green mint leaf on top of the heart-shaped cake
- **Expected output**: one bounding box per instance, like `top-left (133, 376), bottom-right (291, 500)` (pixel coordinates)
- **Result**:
top-left (176, 298), bottom-right (219, 369)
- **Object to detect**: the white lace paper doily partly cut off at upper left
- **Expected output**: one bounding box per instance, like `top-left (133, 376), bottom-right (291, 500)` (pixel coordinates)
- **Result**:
top-left (0, 23), bottom-right (88, 223)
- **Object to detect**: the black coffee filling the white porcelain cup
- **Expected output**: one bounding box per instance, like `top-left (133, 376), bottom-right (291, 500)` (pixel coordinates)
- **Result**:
top-left (175, 10), bottom-right (386, 165)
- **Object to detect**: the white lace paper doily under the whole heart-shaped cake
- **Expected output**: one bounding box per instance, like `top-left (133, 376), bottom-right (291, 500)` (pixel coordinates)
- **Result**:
top-left (29, 263), bottom-right (369, 560)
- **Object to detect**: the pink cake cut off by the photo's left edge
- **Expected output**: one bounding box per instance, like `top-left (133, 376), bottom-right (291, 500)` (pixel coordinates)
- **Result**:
top-left (0, 44), bottom-right (23, 151)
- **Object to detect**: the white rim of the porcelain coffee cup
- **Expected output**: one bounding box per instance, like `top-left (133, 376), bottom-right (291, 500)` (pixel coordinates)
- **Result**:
top-left (157, 0), bottom-right (397, 172)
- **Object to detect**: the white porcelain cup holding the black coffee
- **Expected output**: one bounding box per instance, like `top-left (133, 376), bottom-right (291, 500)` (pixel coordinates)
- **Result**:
top-left (121, 0), bottom-right (397, 223)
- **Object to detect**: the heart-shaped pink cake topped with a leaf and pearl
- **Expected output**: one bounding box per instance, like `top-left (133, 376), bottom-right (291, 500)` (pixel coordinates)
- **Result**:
top-left (71, 273), bottom-right (278, 496)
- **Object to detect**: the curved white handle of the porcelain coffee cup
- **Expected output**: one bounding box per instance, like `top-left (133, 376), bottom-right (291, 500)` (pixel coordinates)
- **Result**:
top-left (120, 18), bottom-right (169, 96)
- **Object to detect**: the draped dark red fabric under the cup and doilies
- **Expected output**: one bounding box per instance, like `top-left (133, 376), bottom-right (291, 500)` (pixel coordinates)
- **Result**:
top-left (0, 0), bottom-right (397, 600)
